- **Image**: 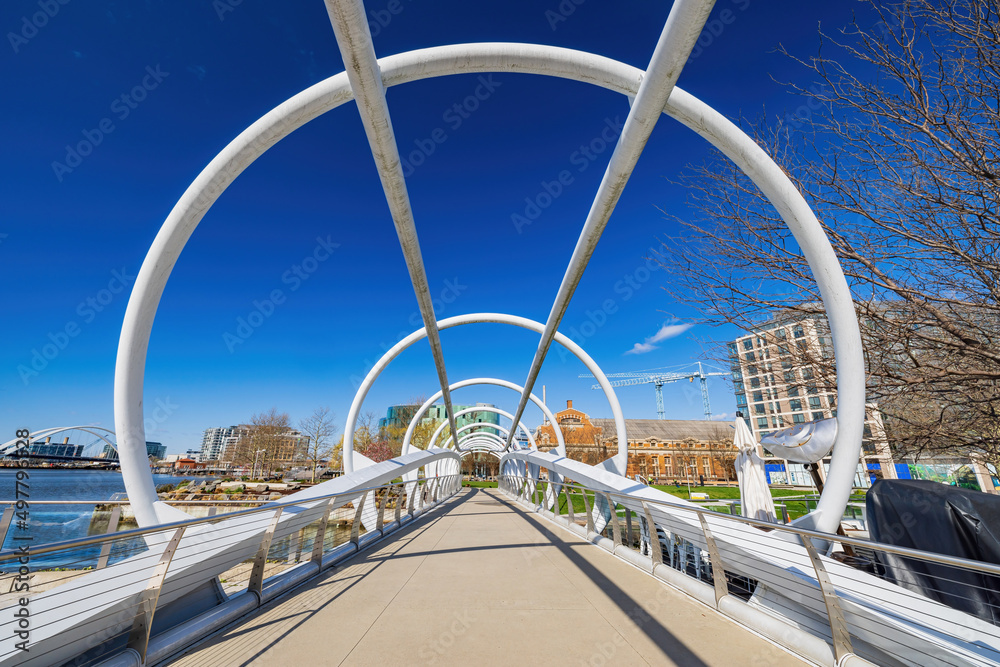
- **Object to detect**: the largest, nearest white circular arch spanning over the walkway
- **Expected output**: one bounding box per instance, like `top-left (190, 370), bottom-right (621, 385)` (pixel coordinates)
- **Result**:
top-left (115, 43), bottom-right (865, 532)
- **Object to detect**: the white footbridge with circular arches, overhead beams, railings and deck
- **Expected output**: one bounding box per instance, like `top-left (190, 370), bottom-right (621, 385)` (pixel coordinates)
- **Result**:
top-left (0, 0), bottom-right (1000, 667)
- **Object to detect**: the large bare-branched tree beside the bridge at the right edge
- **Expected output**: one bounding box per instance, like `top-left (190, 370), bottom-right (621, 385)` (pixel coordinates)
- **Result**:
top-left (662, 0), bottom-right (1000, 465)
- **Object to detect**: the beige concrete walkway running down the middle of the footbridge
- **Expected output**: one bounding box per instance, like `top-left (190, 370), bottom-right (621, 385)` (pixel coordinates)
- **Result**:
top-left (171, 489), bottom-right (806, 667)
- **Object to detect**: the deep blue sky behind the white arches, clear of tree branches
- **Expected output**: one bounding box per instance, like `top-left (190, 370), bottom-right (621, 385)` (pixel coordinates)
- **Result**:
top-left (0, 0), bottom-right (853, 452)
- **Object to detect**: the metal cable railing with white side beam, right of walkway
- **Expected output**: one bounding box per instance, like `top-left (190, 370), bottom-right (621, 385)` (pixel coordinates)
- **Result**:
top-left (500, 469), bottom-right (1000, 665)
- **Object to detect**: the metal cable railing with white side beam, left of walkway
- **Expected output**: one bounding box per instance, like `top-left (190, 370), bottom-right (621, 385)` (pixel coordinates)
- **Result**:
top-left (0, 474), bottom-right (461, 665)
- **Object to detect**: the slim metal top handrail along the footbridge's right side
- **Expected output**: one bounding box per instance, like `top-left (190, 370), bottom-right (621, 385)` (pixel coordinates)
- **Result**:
top-left (500, 475), bottom-right (1000, 576)
